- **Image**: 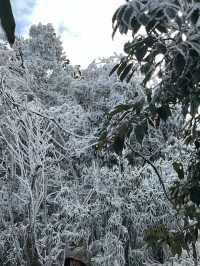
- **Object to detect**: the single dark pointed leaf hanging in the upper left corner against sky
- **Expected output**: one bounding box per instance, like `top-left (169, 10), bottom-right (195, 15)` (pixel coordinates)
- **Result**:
top-left (0, 0), bottom-right (15, 45)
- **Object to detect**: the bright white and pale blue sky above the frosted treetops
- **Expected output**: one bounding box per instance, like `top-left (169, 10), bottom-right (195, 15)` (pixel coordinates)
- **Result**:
top-left (11, 0), bottom-right (130, 66)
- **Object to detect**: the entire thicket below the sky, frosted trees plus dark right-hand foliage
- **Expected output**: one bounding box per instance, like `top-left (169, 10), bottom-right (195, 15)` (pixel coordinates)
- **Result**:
top-left (0, 0), bottom-right (200, 266)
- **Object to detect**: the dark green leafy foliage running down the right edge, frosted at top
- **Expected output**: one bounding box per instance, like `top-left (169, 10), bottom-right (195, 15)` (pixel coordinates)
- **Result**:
top-left (107, 0), bottom-right (200, 258)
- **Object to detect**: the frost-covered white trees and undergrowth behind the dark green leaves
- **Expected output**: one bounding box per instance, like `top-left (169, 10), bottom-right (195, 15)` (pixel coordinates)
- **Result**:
top-left (0, 24), bottom-right (195, 266)
